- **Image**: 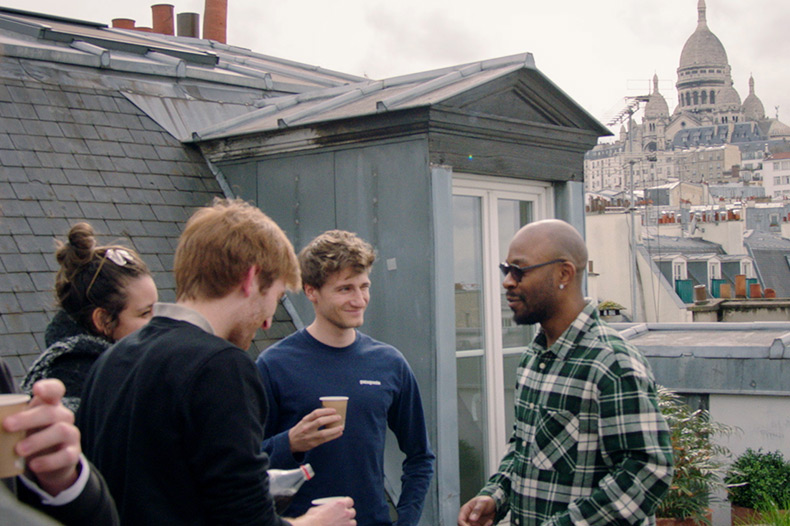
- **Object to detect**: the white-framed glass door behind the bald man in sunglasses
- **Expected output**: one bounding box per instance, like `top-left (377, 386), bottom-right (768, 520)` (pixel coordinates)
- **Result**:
top-left (453, 177), bottom-right (552, 503)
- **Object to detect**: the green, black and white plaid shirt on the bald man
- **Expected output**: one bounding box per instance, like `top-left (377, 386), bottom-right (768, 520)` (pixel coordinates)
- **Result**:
top-left (480, 303), bottom-right (672, 526)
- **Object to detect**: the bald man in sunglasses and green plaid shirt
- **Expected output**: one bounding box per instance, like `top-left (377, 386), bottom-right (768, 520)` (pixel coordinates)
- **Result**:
top-left (458, 219), bottom-right (672, 526)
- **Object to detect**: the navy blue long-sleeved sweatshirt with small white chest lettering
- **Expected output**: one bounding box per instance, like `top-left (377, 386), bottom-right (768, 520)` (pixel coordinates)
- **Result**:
top-left (256, 329), bottom-right (434, 526)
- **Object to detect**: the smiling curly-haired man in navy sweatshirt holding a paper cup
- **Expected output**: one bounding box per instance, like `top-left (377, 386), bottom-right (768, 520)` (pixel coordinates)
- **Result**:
top-left (256, 230), bottom-right (435, 526)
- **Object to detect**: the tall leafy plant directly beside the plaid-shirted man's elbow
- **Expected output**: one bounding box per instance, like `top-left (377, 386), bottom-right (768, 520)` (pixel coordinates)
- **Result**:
top-left (656, 387), bottom-right (733, 524)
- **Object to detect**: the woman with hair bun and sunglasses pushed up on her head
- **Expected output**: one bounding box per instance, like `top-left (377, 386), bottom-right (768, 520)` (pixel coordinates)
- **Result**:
top-left (22, 223), bottom-right (158, 412)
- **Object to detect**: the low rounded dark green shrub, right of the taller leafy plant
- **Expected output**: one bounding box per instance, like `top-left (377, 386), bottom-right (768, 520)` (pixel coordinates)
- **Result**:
top-left (724, 448), bottom-right (790, 509)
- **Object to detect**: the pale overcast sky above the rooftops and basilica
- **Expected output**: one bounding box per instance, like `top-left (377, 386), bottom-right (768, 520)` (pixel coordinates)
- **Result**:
top-left (0, 0), bottom-right (790, 131)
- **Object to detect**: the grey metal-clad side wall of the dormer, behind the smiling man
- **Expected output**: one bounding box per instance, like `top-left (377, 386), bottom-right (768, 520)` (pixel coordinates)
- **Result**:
top-left (222, 138), bottom-right (446, 525)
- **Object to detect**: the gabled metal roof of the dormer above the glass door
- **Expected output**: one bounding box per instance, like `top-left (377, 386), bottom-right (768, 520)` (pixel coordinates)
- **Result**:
top-left (194, 53), bottom-right (610, 141)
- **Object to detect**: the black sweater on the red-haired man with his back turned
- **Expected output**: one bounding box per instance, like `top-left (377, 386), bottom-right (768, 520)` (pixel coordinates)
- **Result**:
top-left (77, 316), bottom-right (284, 526)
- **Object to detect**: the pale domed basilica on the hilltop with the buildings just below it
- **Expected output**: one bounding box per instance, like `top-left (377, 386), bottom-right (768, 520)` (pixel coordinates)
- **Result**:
top-left (584, 0), bottom-right (790, 192)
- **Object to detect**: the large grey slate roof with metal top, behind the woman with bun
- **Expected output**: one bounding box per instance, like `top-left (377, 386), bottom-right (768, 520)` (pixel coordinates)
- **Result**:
top-left (0, 8), bottom-right (360, 377)
